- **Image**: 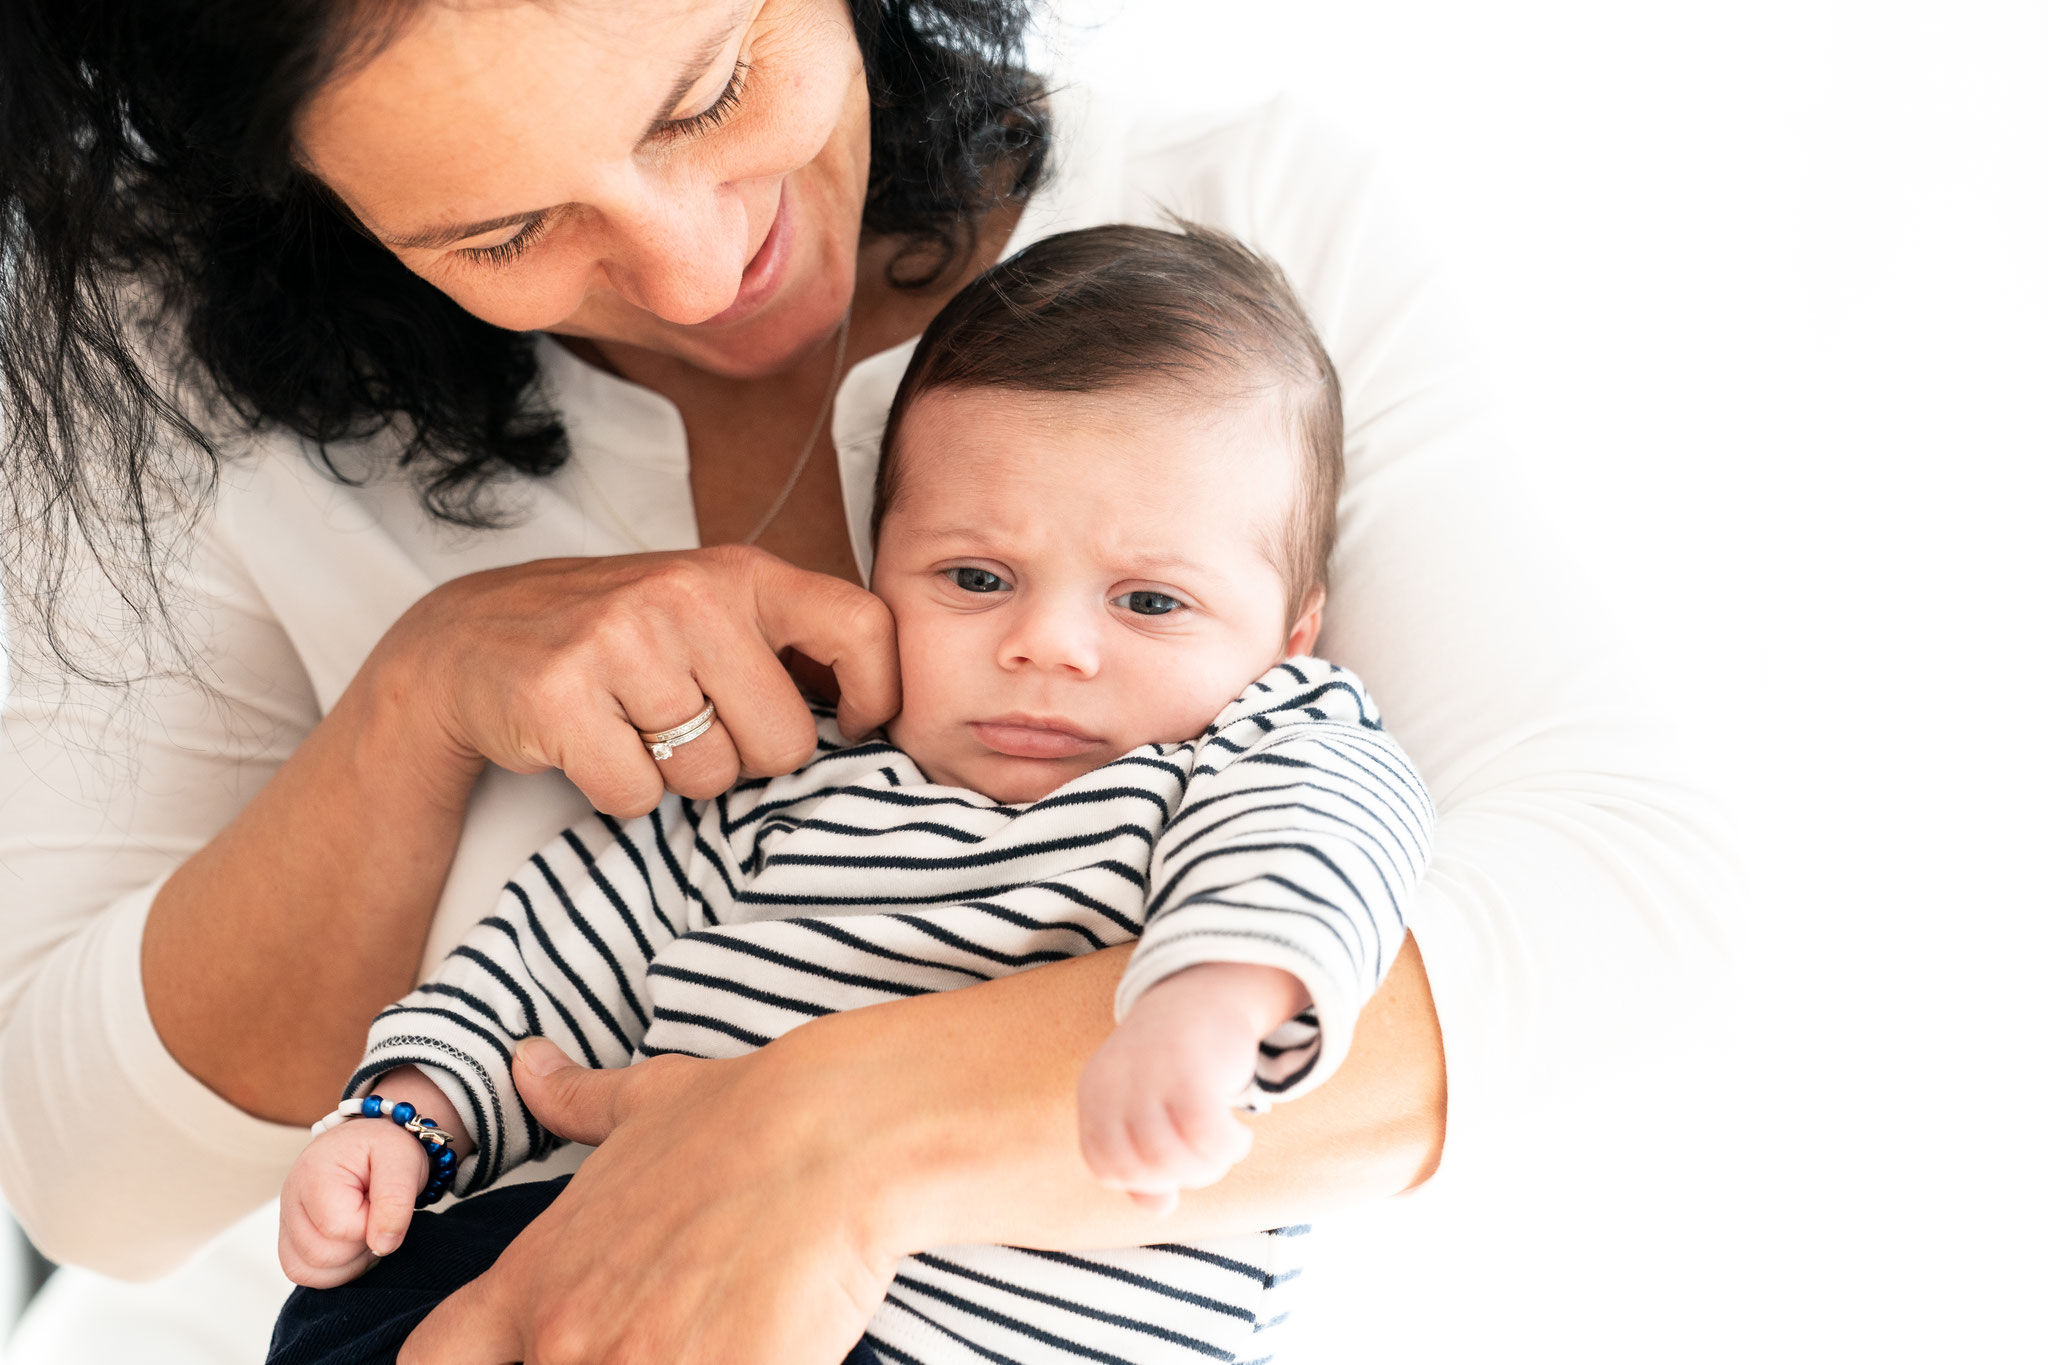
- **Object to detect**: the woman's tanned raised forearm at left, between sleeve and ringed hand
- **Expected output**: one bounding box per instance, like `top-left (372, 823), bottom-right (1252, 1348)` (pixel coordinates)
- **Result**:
top-left (141, 654), bottom-right (479, 1124)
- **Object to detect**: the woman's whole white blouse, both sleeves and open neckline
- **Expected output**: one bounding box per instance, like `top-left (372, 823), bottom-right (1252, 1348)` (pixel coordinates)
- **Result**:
top-left (0, 92), bottom-right (1733, 1277)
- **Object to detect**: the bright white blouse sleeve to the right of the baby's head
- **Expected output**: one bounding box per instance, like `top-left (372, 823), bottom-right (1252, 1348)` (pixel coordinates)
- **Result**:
top-left (1167, 102), bottom-right (1739, 1169)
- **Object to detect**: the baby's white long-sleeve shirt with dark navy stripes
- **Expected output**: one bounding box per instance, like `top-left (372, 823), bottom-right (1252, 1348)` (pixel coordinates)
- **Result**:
top-left (348, 659), bottom-right (1434, 1365)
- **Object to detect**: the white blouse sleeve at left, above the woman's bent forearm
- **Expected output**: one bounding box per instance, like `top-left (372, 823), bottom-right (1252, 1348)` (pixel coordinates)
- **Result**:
top-left (0, 515), bottom-right (317, 1277)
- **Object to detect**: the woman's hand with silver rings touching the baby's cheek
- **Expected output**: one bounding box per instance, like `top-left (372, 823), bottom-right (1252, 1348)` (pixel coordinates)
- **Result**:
top-left (365, 546), bottom-right (899, 817)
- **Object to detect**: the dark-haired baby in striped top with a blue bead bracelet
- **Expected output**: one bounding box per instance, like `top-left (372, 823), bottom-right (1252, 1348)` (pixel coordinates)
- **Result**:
top-left (274, 227), bottom-right (1432, 1365)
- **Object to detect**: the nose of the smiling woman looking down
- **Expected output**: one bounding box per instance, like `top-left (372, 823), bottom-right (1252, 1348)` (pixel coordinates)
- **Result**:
top-left (602, 176), bottom-right (750, 325)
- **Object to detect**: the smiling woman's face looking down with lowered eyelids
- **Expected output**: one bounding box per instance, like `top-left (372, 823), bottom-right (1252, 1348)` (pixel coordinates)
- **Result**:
top-left (299, 0), bottom-right (868, 379)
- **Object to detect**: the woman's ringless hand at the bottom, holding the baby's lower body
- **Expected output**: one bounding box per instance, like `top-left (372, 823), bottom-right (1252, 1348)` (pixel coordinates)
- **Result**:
top-left (399, 1040), bottom-right (897, 1365)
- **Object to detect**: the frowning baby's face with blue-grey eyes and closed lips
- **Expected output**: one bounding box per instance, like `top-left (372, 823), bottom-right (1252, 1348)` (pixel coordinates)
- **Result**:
top-left (874, 389), bottom-right (1321, 802)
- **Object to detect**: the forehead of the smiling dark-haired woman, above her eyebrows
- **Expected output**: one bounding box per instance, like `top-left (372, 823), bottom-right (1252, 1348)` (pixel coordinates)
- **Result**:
top-left (297, 0), bottom-right (756, 241)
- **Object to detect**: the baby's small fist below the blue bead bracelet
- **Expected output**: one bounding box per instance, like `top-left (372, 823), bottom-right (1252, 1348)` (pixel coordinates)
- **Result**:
top-left (276, 1119), bottom-right (426, 1289)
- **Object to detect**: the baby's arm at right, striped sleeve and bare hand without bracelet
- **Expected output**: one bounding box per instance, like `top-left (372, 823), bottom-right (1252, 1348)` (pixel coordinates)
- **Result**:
top-left (1079, 659), bottom-right (1434, 1209)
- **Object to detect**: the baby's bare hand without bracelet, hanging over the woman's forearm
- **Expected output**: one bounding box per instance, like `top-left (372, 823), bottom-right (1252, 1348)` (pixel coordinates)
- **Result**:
top-left (1079, 962), bottom-right (1307, 1216)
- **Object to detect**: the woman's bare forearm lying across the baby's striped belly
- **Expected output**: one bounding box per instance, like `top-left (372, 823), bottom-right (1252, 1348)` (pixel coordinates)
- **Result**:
top-left (778, 941), bottom-right (1444, 1252)
